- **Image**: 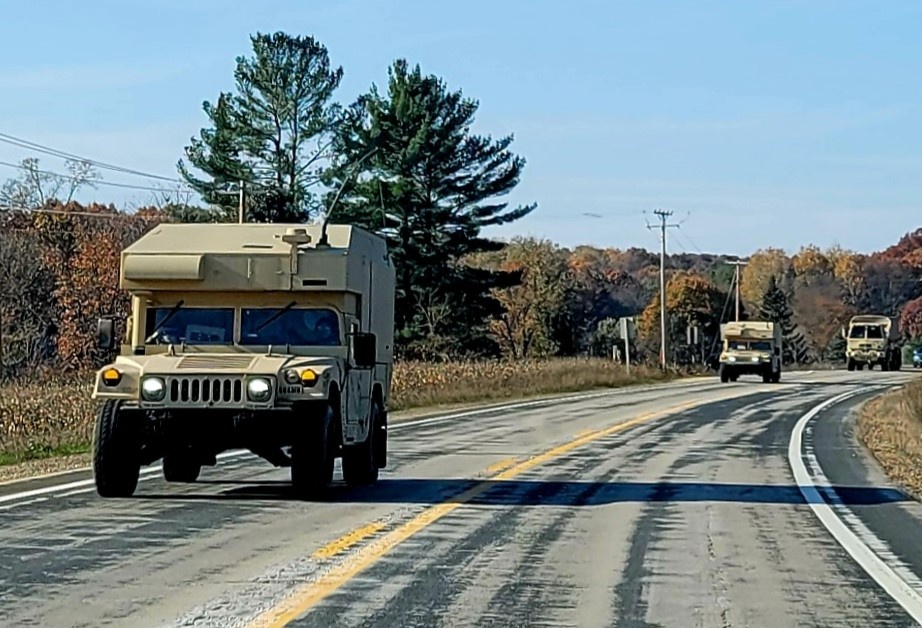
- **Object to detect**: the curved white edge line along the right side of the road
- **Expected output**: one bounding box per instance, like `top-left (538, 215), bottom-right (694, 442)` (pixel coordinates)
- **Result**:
top-left (788, 390), bottom-right (922, 624)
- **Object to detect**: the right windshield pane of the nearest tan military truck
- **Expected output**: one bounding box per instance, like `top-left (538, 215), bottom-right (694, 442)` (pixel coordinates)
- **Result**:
top-left (240, 307), bottom-right (341, 347)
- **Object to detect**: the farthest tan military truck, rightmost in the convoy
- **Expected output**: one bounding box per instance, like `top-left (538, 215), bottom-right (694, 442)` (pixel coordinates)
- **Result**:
top-left (842, 314), bottom-right (903, 371)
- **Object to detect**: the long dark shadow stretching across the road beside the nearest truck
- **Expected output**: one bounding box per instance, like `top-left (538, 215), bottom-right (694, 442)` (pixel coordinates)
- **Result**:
top-left (136, 478), bottom-right (910, 507)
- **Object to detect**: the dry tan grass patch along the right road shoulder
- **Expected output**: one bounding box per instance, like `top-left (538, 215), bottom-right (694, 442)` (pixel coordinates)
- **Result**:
top-left (858, 381), bottom-right (922, 499)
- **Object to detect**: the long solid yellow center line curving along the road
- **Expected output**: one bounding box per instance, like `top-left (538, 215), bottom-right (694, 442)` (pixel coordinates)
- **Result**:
top-left (248, 392), bottom-right (747, 628)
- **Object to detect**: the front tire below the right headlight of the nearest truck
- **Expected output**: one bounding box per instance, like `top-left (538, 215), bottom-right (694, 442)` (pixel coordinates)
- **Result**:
top-left (291, 404), bottom-right (336, 499)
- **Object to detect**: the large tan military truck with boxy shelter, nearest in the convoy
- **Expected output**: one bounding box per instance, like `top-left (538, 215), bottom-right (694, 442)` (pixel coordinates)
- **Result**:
top-left (93, 224), bottom-right (395, 497)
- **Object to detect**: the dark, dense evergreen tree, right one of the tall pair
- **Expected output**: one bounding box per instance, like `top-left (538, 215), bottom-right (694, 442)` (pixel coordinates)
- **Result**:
top-left (329, 59), bottom-right (535, 353)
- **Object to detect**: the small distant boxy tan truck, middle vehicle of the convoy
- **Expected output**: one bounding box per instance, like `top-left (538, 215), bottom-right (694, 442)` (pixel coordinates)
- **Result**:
top-left (719, 321), bottom-right (781, 384)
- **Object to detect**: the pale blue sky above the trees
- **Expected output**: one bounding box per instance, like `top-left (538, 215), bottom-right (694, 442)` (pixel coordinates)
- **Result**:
top-left (0, 0), bottom-right (922, 255)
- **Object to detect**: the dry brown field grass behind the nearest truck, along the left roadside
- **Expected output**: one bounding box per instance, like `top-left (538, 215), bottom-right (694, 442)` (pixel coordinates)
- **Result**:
top-left (0, 359), bottom-right (675, 465)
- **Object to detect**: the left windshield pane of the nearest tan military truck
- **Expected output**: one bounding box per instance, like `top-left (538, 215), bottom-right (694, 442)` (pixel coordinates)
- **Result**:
top-left (145, 306), bottom-right (234, 345)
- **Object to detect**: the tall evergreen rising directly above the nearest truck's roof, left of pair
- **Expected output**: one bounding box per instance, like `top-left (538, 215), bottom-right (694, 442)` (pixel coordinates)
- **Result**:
top-left (178, 32), bottom-right (343, 222)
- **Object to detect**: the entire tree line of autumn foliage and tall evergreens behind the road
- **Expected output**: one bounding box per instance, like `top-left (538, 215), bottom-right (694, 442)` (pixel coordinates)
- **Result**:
top-left (0, 33), bottom-right (922, 374)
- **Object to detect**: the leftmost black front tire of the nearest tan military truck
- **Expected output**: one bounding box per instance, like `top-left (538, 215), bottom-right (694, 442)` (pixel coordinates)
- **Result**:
top-left (93, 400), bottom-right (141, 497)
